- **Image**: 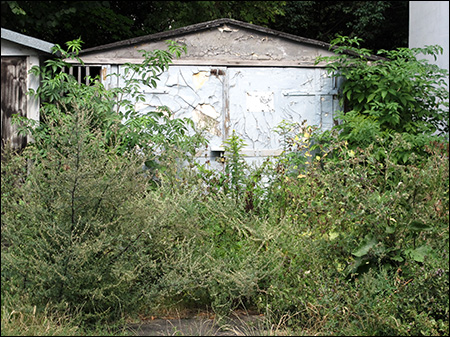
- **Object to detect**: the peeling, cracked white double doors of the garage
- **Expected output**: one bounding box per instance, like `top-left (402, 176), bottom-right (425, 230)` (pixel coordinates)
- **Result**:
top-left (113, 66), bottom-right (338, 167)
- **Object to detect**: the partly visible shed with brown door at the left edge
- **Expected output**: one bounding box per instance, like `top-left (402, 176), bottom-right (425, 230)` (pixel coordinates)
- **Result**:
top-left (1, 28), bottom-right (53, 152)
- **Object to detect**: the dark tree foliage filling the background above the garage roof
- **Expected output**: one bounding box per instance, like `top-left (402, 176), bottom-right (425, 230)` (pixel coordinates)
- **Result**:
top-left (1, 1), bottom-right (408, 49)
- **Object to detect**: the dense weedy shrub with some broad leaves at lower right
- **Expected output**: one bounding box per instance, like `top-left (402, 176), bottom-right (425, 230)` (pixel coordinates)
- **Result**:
top-left (272, 131), bottom-right (449, 335)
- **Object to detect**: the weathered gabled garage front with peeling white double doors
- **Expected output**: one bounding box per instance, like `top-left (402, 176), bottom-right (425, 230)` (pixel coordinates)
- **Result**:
top-left (70, 19), bottom-right (339, 166)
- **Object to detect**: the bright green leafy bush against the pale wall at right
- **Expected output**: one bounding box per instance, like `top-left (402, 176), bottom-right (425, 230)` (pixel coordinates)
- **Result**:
top-left (319, 36), bottom-right (449, 134)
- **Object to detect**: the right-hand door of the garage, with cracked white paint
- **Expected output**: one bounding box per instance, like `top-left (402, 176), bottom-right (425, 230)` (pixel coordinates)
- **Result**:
top-left (228, 68), bottom-right (338, 151)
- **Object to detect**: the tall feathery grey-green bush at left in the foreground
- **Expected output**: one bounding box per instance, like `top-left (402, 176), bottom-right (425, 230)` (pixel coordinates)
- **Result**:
top-left (2, 107), bottom-right (158, 322)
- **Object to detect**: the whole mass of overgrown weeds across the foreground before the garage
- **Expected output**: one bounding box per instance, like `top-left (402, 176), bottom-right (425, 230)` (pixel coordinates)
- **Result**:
top-left (1, 35), bottom-right (449, 335)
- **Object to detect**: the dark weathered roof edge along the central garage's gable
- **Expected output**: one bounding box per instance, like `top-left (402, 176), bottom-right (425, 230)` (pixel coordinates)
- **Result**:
top-left (80, 18), bottom-right (331, 56)
